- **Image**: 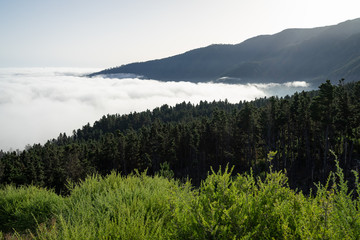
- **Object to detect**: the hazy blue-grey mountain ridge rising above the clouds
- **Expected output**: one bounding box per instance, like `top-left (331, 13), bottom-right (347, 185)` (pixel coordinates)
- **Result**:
top-left (90, 18), bottom-right (360, 84)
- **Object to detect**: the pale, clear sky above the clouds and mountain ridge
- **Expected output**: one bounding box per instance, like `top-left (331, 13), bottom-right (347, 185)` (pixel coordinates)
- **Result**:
top-left (0, 0), bottom-right (360, 68)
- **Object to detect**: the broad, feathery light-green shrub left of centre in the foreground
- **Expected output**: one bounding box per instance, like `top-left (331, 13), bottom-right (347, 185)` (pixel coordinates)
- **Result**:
top-left (53, 173), bottom-right (190, 239)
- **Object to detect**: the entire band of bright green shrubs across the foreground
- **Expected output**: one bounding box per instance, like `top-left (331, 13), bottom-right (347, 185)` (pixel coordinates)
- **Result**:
top-left (0, 160), bottom-right (360, 240)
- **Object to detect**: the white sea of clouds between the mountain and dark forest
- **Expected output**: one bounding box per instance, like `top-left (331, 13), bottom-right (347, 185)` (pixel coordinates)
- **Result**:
top-left (0, 68), bottom-right (309, 151)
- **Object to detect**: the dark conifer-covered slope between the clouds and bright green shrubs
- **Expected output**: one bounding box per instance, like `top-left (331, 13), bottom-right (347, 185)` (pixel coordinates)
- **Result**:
top-left (0, 81), bottom-right (360, 194)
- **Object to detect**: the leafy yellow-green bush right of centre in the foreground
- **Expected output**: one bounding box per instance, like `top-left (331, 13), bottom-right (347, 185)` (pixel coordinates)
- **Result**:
top-left (173, 168), bottom-right (305, 239)
